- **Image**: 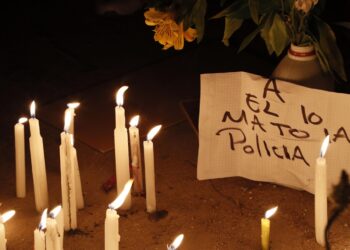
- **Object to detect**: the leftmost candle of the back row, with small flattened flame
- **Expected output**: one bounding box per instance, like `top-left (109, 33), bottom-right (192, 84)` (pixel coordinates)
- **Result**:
top-left (15, 117), bottom-right (28, 198)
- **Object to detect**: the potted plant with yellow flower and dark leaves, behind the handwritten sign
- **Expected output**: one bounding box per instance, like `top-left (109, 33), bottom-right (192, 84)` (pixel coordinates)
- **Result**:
top-left (145, 0), bottom-right (347, 89)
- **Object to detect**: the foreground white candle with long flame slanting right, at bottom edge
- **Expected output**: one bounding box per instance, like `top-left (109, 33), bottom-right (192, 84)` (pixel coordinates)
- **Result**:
top-left (105, 180), bottom-right (133, 250)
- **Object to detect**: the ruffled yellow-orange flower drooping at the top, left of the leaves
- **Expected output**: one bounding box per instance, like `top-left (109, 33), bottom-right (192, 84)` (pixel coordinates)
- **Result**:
top-left (144, 8), bottom-right (197, 50)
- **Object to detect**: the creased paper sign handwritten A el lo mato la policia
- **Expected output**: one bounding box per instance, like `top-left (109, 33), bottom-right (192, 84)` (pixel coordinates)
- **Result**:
top-left (197, 72), bottom-right (350, 193)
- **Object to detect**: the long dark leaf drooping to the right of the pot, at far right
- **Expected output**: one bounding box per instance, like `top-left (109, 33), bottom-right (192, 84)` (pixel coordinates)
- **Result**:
top-left (316, 18), bottom-right (347, 81)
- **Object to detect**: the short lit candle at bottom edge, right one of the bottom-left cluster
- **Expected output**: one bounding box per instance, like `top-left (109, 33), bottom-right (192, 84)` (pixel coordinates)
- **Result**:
top-left (46, 206), bottom-right (63, 250)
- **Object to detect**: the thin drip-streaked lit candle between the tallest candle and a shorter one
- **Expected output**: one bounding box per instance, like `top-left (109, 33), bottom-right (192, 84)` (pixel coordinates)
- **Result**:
top-left (129, 115), bottom-right (143, 193)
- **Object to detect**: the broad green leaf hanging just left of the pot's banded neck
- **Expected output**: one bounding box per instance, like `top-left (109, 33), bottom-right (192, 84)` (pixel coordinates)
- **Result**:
top-left (265, 13), bottom-right (290, 56)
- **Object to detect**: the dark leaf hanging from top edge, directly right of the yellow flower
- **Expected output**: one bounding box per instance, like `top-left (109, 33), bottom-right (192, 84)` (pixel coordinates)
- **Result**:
top-left (191, 0), bottom-right (207, 43)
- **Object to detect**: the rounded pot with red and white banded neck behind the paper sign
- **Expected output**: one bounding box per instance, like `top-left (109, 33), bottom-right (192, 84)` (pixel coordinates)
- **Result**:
top-left (272, 44), bottom-right (334, 91)
